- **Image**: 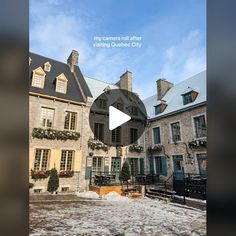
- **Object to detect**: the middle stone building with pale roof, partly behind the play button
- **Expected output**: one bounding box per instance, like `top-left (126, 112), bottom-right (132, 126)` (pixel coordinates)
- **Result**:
top-left (82, 71), bottom-right (145, 184)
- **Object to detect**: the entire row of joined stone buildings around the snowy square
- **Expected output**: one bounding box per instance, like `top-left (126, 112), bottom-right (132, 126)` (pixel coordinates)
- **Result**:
top-left (29, 50), bottom-right (206, 192)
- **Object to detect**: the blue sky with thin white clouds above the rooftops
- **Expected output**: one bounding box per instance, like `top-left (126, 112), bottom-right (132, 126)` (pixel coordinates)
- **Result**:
top-left (30, 0), bottom-right (206, 98)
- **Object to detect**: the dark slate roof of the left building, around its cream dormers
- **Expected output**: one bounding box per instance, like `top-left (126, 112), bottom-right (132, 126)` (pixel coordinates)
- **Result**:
top-left (29, 52), bottom-right (92, 102)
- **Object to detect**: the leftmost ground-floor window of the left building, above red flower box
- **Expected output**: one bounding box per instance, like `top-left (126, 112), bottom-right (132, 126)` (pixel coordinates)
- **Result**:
top-left (34, 148), bottom-right (49, 171)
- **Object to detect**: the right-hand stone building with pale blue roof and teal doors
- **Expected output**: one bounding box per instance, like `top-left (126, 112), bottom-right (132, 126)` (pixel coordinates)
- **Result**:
top-left (144, 71), bottom-right (207, 180)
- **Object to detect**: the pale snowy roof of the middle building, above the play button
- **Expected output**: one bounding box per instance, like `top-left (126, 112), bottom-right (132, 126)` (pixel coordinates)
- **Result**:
top-left (84, 76), bottom-right (119, 100)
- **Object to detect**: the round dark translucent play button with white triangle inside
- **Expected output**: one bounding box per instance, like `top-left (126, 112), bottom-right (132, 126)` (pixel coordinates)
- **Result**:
top-left (89, 88), bottom-right (147, 147)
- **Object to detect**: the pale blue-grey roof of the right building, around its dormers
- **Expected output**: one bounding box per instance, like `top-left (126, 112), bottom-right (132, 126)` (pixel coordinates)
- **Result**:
top-left (143, 71), bottom-right (206, 119)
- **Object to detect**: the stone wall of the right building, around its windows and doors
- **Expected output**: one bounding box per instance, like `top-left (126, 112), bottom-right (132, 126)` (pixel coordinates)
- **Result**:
top-left (145, 106), bottom-right (207, 180)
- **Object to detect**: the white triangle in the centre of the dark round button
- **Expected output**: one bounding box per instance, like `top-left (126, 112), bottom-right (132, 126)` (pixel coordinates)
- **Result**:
top-left (109, 106), bottom-right (131, 130)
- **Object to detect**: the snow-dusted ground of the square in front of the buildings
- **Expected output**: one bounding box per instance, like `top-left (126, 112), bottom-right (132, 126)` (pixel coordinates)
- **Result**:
top-left (30, 193), bottom-right (206, 236)
